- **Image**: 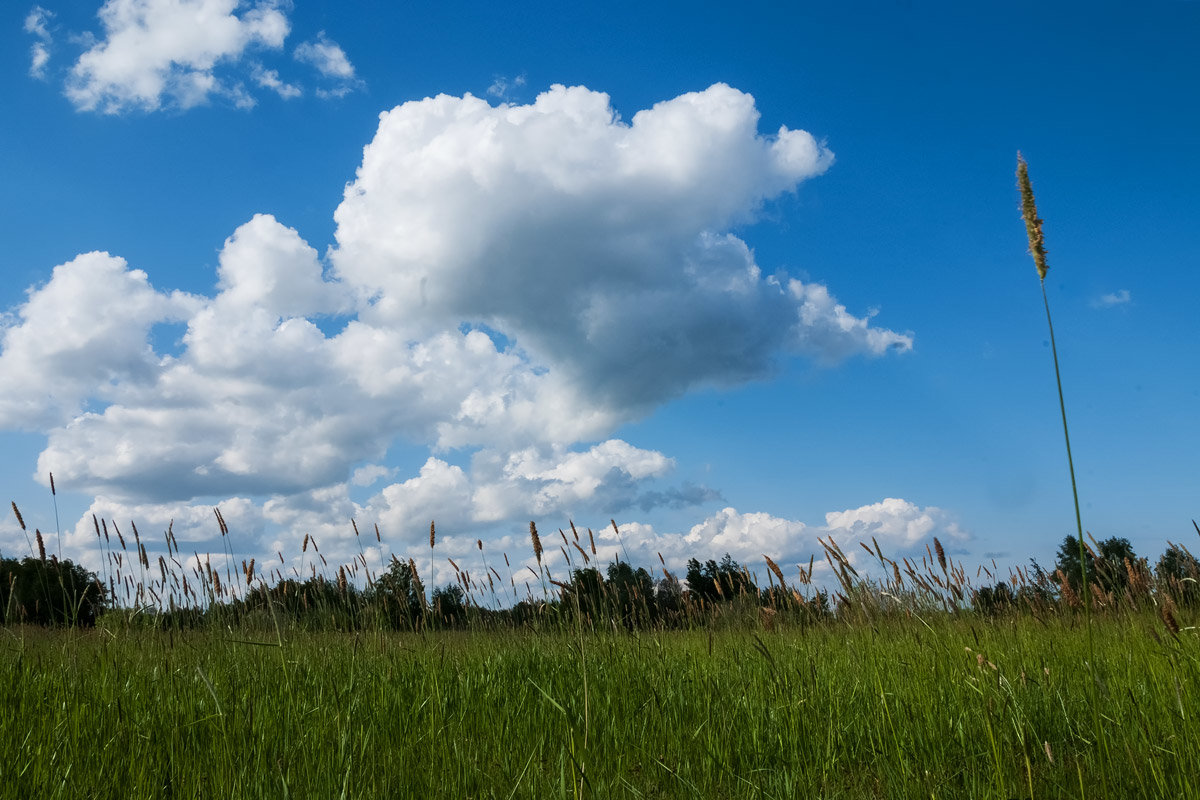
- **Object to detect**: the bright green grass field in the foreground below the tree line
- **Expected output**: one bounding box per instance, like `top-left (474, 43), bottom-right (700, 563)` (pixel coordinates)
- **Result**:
top-left (0, 613), bottom-right (1200, 799)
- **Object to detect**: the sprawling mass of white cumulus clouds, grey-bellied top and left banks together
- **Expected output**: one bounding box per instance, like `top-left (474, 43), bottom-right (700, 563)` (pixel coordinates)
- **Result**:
top-left (0, 84), bottom-right (912, 566)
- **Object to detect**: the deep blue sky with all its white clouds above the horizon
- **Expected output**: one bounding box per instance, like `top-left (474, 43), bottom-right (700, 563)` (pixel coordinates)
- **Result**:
top-left (0, 0), bottom-right (1200, 592)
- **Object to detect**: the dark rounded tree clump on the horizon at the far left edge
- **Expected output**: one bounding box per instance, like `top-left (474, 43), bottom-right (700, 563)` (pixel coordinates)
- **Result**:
top-left (0, 555), bottom-right (109, 627)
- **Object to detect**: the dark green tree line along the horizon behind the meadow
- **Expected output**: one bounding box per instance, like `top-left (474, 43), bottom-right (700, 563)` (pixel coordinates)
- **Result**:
top-left (0, 536), bottom-right (1200, 631)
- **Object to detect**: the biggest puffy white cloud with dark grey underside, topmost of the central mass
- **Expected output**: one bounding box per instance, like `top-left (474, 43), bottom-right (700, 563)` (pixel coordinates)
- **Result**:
top-left (332, 84), bottom-right (912, 414)
